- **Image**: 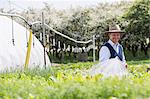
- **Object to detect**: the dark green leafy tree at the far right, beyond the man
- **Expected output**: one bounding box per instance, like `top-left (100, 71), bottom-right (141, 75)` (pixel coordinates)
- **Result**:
top-left (123, 0), bottom-right (150, 56)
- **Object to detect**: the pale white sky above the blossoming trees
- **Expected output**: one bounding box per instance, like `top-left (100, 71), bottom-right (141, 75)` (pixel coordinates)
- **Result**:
top-left (0, 0), bottom-right (133, 11)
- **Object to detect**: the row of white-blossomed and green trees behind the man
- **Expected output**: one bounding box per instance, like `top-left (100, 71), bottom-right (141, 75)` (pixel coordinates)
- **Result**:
top-left (0, 0), bottom-right (150, 62)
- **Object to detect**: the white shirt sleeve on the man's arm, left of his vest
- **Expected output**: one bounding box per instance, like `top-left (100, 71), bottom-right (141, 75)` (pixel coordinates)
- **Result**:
top-left (99, 46), bottom-right (110, 62)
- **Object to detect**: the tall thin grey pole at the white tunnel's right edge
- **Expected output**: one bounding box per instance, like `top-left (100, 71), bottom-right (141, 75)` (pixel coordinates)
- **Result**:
top-left (42, 12), bottom-right (46, 69)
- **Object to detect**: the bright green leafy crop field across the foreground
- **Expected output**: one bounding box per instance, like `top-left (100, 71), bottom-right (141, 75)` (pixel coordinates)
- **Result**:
top-left (0, 60), bottom-right (150, 99)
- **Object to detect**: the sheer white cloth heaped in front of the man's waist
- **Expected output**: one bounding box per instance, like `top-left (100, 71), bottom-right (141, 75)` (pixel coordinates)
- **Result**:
top-left (89, 58), bottom-right (128, 77)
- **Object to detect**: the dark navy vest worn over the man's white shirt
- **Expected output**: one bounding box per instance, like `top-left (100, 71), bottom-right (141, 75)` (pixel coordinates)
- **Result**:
top-left (102, 42), bottom-right (123, 61)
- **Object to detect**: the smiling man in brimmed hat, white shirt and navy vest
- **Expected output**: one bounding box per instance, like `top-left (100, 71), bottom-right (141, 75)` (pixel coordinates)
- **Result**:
top-left (99, 25), bottom-right (127, 68)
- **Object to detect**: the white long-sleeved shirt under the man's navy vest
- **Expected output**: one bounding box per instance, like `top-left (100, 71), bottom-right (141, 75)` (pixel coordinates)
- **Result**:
top-left (99, 40), bottom-right (126, 65)
